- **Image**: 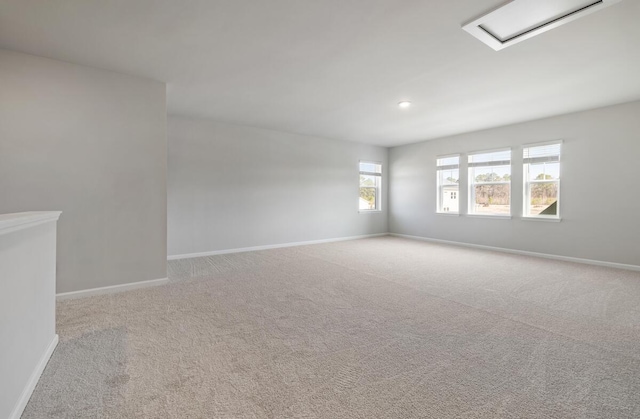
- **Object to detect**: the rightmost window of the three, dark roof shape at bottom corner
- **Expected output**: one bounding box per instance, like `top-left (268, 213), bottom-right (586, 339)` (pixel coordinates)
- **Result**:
top-left (522, 143), bottom-right (561, 218)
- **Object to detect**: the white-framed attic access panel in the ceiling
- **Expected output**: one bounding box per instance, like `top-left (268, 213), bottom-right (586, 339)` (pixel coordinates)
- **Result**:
top-left (462, 0), bottom-right (621, 51)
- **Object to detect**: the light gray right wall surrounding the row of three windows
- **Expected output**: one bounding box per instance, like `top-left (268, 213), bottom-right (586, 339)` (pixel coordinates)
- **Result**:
top-left (389, 102), bottom-right (640, 265)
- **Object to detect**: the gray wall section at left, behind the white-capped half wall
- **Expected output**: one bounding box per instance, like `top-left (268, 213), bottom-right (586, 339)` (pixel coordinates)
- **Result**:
top-left (0, 50), bottom-right (167, 292)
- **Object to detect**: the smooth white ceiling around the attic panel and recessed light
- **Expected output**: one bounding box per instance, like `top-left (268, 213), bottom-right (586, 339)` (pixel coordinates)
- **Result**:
top-left (0, 0), bottom-right (640, 146)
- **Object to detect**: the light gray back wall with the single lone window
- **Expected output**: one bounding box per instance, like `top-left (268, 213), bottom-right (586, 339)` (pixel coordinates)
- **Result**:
top-left (168, 117), bottom-right (388, 255)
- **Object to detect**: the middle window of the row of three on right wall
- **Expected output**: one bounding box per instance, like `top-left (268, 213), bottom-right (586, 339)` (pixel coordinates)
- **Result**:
top-left (469, 150), bottom-right (511, 216)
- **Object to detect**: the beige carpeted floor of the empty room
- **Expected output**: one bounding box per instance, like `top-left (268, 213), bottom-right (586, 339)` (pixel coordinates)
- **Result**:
top-left (23, 237), bottom-right (640, 419)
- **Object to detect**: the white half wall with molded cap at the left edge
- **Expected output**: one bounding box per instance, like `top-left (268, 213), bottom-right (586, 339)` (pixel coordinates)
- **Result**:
top-left (0, 212), bottom-right (60, 419)
